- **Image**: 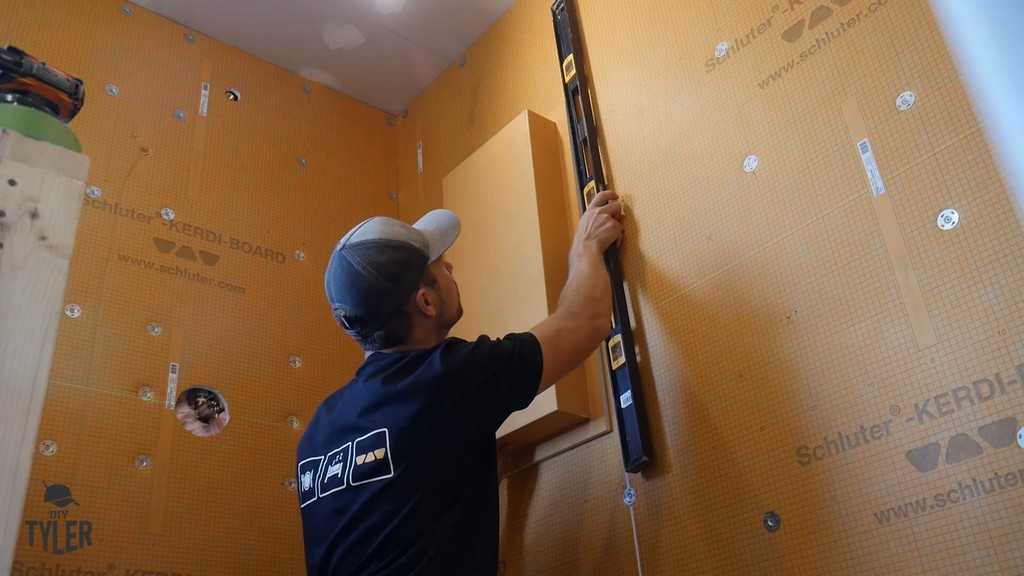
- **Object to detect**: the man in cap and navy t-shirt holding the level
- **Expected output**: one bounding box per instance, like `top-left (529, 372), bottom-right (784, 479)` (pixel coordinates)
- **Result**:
top-left (298, 191), bottom-right (622, 576)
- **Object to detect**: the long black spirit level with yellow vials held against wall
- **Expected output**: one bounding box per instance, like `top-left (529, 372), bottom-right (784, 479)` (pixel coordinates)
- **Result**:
top-left (551, 0), bottom-right (653, 472)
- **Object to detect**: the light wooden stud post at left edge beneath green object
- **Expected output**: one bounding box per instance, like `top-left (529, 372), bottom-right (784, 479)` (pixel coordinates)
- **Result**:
top-left (0, 129), bottom-right (89, 574)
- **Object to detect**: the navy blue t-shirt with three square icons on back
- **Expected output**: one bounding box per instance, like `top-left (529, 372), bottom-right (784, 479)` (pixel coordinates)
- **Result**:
top-left (298, 333), bottom-right (543, 576)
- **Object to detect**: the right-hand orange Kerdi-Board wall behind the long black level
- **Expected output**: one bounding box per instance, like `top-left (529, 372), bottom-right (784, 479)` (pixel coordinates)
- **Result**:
top-left (397, 0), bottom-right (1024, 575)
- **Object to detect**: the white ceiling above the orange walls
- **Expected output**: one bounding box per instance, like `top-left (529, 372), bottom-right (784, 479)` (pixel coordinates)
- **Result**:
top-left (130, 0), bottom-right (515, 115)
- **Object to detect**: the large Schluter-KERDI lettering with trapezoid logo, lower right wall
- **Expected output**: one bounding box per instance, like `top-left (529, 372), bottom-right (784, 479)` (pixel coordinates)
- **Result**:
top-left (797, 364), bottom-right (1024, 474)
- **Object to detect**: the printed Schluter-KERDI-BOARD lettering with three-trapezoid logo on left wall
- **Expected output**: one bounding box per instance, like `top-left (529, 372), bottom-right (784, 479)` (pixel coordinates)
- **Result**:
top-left (82, 196), bottom-right (288, 265)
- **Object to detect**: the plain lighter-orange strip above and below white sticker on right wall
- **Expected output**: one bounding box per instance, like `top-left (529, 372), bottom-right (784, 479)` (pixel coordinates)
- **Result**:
top-left (843, 98), bottom-right (938, 349)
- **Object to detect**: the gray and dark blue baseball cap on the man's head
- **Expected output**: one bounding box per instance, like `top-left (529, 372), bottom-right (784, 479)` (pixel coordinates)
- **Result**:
top-left (324, 209), bottom-right (461, 340)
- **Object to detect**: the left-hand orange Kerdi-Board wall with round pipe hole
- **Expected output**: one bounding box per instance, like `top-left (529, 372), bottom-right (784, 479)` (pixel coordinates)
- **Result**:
top-left (0, 0), bottom-right (397, 576)
